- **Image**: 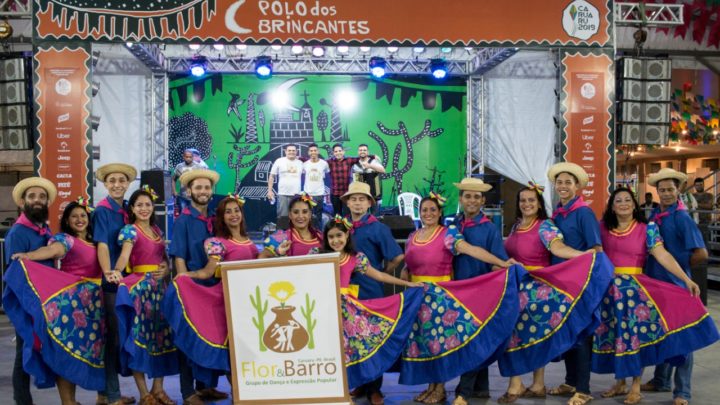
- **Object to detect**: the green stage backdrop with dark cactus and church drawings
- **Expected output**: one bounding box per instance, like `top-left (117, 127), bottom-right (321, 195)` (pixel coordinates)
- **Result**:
top-left (168, 74), bottom-right (467, 229)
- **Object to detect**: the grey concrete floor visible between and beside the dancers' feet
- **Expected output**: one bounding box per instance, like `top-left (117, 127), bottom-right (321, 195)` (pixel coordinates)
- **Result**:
top-left (0, 290), bottom-right (720, 405)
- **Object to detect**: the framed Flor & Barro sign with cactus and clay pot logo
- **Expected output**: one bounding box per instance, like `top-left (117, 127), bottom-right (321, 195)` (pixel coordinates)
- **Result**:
top-left (220, 253), bottom-right (350, 404)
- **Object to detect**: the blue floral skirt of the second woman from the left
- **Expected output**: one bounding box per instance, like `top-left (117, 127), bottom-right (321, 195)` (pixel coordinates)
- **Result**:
top-left (115, 273), bottom-right (179, 378)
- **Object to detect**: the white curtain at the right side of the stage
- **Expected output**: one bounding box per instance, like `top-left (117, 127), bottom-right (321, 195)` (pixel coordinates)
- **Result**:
top-left (485, 51), bottom-right (557, 212)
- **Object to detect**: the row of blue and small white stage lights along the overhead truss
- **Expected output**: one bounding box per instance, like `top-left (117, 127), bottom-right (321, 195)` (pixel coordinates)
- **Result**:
top-left (189, 44), bottom-right (452, 80)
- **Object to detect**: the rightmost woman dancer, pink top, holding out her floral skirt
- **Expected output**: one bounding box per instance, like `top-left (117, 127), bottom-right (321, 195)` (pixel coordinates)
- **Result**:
top-left (593, 188), bottom-right (718, 404)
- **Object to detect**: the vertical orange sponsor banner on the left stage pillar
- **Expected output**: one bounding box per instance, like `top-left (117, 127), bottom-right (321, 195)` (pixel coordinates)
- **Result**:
top-left (33, 43), bottom-right (92, 232)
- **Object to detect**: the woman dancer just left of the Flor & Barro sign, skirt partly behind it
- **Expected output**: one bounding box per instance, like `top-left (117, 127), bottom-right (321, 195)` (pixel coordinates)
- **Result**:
top-left (163, 195), bottom-right (258, 386)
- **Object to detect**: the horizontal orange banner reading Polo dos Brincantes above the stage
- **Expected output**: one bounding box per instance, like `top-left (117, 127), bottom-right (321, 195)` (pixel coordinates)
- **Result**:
top-left (34, 0), bottom-right (612, 47)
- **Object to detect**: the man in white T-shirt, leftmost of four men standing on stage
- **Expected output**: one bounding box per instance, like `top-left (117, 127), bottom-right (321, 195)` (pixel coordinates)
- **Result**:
top-left (267, 145), bottom-right (303, 218)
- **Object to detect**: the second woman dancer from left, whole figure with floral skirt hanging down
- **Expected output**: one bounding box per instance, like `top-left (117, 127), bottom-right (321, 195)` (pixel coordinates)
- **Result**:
top-left (115, 186), bottom-right (178, 405)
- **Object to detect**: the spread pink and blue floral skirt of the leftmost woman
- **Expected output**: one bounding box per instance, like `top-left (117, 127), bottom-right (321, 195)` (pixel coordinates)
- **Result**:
top-left (3, 260), bottom-right (105, 391)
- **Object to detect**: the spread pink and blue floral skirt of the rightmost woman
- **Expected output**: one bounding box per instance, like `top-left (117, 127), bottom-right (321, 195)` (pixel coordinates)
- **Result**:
top-left (592, 274), bottom-right (719, 378)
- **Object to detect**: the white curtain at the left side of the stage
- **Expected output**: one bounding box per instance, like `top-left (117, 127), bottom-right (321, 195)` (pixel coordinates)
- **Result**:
top-left (92, 75), bottom-right (151, 204)
